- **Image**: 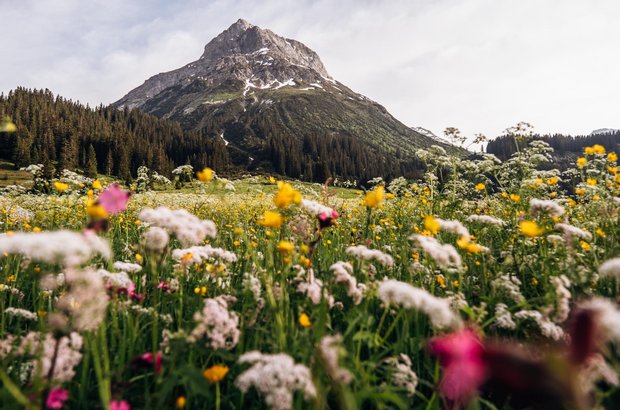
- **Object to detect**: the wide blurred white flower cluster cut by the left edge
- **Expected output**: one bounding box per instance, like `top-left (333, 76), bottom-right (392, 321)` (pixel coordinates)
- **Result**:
top-left (0, 230), bottom-right (112, 266)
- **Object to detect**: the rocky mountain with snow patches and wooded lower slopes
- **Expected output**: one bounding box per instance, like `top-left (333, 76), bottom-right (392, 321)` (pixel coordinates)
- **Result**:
top-left (115, 19), bottom-right (452, 180)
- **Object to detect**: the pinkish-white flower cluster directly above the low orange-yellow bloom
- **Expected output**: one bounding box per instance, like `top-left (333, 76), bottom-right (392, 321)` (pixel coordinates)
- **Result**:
top-left (188, 295), bottom-right (240, 350)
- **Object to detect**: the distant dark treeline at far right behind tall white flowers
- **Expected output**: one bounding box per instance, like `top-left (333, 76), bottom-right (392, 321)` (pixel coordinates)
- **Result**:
top-left (487, 131), bottom-right (620, 160)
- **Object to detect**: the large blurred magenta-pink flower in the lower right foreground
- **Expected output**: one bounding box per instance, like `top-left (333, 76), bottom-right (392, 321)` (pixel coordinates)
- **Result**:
top-left (430, 329), bottom-right (487, 401)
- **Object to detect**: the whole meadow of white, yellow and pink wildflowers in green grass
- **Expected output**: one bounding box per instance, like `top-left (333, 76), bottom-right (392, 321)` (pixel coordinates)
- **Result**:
top-left (0, 141), bottom-right (620, 410)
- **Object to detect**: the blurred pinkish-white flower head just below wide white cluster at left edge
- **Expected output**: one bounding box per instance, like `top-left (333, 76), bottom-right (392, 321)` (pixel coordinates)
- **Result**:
top-left (55, 269), bottom-right (109, 331)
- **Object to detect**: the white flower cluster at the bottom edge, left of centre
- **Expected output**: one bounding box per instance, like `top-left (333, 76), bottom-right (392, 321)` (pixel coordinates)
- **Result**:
top-left (235, 350), bottom-right (316, 410)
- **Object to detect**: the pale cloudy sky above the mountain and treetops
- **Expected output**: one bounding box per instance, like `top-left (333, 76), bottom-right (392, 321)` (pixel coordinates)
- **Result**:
top-left (0, 0), bottom-right (620, 140)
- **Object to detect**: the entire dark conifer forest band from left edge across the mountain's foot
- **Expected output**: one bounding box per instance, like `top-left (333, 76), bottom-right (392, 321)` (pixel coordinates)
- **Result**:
top-left (0, 88), bottom-right (432, 182)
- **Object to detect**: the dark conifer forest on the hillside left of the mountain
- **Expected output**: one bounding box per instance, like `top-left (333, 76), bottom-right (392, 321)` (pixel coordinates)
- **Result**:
top-left (0, 88), bottom-right (231, 179)
